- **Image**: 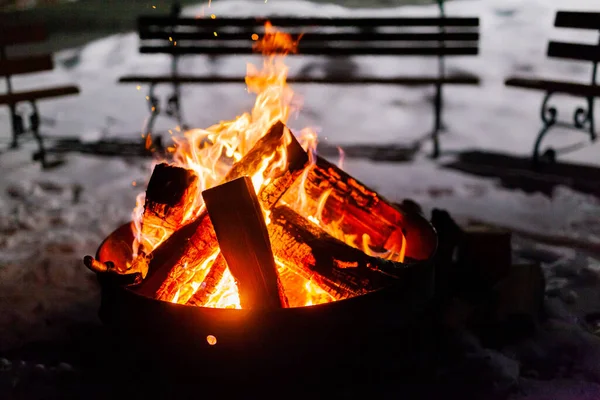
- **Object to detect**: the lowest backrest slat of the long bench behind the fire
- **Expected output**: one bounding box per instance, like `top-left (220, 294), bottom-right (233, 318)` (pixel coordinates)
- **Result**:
top-left (140, 43), bottom-right (479, 56)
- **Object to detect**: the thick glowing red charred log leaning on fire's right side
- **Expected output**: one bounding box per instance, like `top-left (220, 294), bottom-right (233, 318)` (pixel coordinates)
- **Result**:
top-left (283, 157), bottom-right (437, 261)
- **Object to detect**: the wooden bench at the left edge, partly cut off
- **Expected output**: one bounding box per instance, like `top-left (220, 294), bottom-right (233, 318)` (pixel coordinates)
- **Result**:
top-left (0, 24), bottom-right (79, 168)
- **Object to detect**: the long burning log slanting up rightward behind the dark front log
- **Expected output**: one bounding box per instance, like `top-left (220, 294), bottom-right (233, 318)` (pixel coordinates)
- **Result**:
top-left (132, 122), bottom-right (308, 300)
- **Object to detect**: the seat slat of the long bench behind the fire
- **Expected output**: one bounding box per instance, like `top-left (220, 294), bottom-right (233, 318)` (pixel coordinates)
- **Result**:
top-left (119, 75), bottom-right (479, 86)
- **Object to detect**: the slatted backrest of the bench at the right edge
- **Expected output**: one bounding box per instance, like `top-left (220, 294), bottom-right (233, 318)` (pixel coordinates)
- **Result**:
top-left (548, 11), bottom-right (600, 83)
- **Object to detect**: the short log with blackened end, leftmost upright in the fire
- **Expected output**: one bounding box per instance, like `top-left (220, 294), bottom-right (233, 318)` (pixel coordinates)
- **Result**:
top-left (141, 163), bottom-right (197, 251)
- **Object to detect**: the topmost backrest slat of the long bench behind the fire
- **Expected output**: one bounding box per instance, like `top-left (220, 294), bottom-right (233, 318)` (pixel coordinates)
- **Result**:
top-left (138, 15), bottom-right (479, 28)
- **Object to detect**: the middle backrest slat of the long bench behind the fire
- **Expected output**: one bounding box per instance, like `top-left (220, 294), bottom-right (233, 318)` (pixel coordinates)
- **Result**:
top-left (139, 30), bottom-right (479, 43)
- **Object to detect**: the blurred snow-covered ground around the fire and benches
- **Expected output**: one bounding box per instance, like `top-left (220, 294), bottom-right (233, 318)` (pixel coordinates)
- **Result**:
top-left (0, 0), bottom-right (600, 399)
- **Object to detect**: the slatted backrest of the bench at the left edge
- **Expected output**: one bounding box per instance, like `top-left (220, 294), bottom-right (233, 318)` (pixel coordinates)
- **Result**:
top-left (0, 25), bottom-right (54, 93)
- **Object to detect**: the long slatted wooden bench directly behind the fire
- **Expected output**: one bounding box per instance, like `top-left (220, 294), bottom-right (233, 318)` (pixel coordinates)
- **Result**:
top-left (119, 6), bottom-right (479, 157)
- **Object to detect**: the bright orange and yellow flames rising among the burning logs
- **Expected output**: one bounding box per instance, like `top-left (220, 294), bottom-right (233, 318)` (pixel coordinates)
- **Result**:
top-left (133, 21), bottom-right (405, 308)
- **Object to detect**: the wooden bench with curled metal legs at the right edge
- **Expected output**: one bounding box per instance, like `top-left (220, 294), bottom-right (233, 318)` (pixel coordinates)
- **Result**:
top-left (505, 11), bottom-right (600, 167)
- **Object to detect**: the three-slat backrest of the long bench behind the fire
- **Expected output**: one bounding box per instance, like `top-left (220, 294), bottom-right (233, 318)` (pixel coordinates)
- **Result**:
top-left (138, 16), bottom-right (479, 57)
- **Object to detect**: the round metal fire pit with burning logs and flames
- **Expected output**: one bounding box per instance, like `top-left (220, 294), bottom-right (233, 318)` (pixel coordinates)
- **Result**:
top-left (85, 22), bottom-right (437, 377)
